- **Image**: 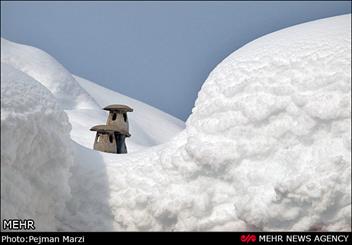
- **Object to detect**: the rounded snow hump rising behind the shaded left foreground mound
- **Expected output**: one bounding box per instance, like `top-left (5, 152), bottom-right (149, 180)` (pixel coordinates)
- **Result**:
top-left (1, 38), bottom-right (97, 109)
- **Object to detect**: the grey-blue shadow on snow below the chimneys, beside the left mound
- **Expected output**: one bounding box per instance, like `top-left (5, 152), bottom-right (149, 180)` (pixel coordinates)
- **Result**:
top-left (60, 141), bottom-right (114, 231)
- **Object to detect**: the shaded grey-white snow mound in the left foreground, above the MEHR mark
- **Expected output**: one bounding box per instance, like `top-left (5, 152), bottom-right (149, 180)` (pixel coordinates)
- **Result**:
top-left (1, 63), bottom-right (73, 230)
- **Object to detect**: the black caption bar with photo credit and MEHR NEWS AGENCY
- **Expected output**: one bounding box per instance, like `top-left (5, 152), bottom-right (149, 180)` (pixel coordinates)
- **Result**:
top-left (1, 232), bottom-right (352, 245)
